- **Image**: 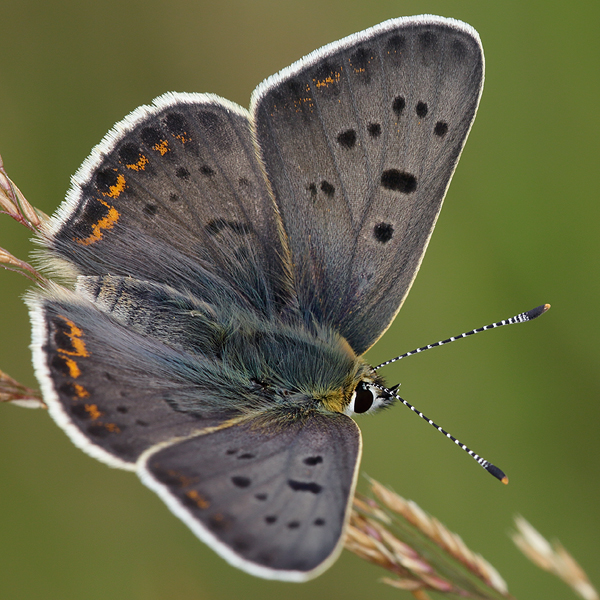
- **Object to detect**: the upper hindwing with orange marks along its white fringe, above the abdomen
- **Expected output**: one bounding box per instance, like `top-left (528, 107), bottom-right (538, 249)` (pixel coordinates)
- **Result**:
top-left (43, 94), bottom-right (290, 314)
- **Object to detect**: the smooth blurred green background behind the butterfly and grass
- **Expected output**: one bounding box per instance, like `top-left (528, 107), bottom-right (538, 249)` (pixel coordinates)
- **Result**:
top-left (0, 0), bottom-right (600, 600)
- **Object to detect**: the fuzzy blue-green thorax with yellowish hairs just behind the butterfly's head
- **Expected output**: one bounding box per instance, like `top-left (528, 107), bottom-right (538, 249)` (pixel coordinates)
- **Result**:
top-left (209, 316), bottom-right (373, 412)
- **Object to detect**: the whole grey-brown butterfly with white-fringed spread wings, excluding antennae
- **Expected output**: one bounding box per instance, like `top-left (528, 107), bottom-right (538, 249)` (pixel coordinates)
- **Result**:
top-left (22, 16), bottom-right (484, 581)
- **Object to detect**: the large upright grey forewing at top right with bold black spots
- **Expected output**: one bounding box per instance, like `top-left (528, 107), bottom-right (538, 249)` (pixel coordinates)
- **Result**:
top-left (252, 16), bottom-right (484, 354)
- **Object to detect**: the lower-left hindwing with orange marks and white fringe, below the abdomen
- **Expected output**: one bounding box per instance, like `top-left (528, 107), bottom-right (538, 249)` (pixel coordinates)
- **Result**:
top-left (28, 286), bottom-right (230, 470)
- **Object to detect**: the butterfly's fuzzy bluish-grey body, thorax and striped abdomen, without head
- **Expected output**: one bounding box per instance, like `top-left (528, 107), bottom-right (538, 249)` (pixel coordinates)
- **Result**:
top-left (77, 276), bottom-right (374, 417)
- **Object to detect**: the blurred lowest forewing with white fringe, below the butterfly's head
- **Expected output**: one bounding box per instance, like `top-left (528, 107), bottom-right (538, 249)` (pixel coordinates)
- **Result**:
top-left (139, 413), bottom-right (361, 581)
